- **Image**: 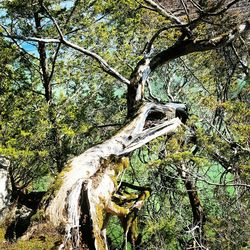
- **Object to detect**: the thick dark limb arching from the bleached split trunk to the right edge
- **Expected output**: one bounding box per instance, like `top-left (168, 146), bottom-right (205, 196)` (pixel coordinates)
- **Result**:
top-left (127, 20), bottom-right (250, 116)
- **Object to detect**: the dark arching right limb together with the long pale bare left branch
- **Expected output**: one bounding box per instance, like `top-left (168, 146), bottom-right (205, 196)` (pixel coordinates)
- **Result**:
top-left (1, 17), bottom-right (250, 102)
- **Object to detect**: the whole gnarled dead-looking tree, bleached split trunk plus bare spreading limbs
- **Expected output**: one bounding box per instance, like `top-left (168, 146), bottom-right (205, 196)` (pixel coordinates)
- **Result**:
top-left (0, 0), bottom-right (250, 249)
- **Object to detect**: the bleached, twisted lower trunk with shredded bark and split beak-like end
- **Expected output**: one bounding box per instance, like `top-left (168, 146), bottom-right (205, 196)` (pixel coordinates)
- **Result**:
top-left (46, 103), bottom-right (185, 250)
